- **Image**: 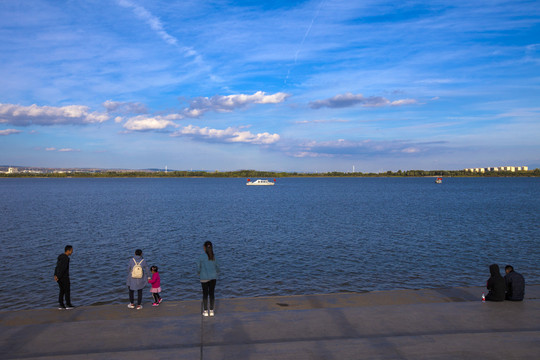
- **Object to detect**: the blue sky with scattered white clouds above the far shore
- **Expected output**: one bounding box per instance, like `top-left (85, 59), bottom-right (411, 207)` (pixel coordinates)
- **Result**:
top-left (0, 0), bottom-right (540, 172)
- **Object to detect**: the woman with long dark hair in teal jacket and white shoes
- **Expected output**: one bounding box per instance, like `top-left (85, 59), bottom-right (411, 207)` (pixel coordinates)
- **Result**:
top-left (197, 241), bottom-right (219, 316)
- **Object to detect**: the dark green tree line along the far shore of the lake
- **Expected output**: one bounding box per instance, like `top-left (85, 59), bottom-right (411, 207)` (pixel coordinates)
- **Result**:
top-left (0, 168), bottom-right (540, 178)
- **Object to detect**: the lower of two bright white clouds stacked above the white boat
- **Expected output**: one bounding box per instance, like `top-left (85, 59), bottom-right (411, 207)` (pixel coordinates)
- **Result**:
top-left (172, 125), bottom-right (280, 145)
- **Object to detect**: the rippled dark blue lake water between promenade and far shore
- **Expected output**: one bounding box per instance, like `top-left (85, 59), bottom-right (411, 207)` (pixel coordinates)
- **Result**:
top-left (0, 178), bottom-right (540, 310)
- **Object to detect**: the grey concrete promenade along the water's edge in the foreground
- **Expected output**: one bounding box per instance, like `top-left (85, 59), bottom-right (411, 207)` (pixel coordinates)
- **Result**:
top-left (0, 285), bottom-right (540, 360)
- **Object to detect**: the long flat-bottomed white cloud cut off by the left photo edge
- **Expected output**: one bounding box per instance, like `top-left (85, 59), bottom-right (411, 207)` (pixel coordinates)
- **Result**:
top-left (0, 104), bottom-right (109, 126)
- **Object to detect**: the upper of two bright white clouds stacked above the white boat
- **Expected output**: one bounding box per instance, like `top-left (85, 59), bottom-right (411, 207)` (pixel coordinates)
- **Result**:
top-left (184, 91), bottom-right (290, 117)
